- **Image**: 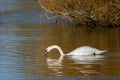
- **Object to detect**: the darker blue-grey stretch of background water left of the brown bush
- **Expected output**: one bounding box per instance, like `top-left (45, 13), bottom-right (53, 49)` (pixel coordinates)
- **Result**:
top-left (0, 0), bottom-right (69, 24)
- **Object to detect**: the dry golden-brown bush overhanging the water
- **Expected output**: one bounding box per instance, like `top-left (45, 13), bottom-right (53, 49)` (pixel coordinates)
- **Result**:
top-left (38, 0), bottom-right (120, 25)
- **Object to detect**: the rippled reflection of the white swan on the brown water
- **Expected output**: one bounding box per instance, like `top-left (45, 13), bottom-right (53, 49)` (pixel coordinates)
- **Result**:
top-left (46, 55), bottom-right (104, 76)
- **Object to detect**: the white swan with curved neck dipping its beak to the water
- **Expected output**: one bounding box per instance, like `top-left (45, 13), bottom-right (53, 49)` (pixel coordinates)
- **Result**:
top-left (45, 45), bottom-right (107, 56)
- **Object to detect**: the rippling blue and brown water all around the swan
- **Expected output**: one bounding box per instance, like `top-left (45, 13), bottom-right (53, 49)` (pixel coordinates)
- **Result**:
top-left (0, 0), bottom-right (120, 80)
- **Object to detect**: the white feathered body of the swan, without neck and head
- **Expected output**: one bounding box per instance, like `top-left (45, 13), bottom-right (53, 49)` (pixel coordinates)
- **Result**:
top-left (67, 46), bottom-right (103, 55)
